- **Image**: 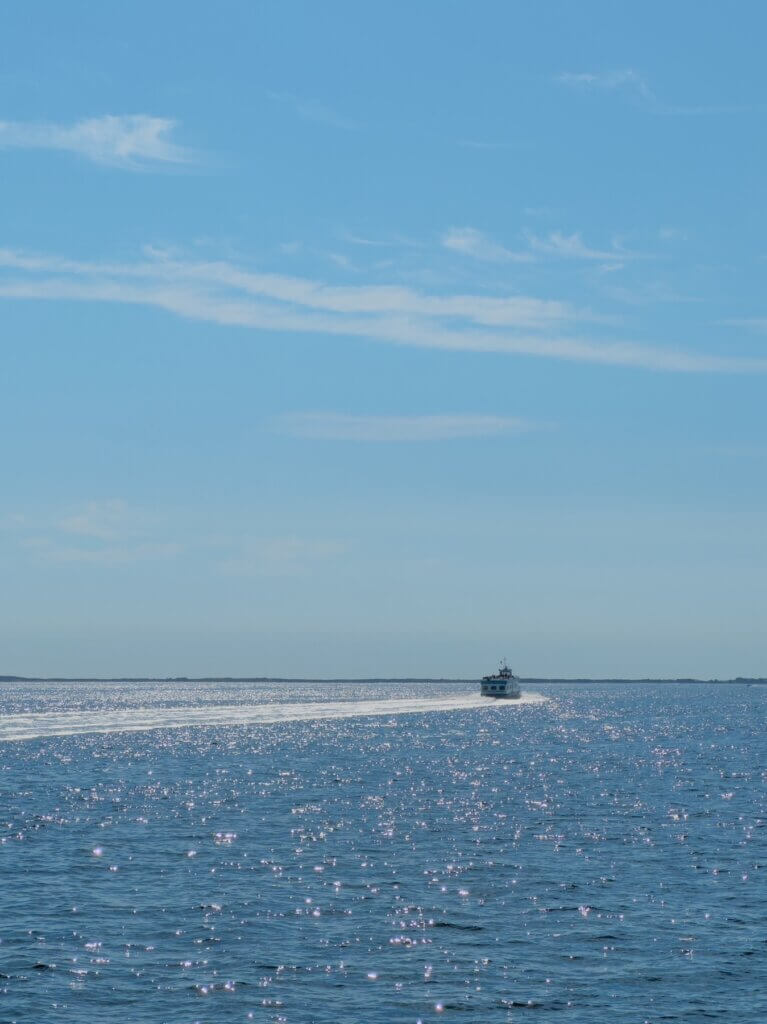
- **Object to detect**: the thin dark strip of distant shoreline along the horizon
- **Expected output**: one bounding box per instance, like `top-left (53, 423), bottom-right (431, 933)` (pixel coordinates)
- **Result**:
top-left (0, 676), bottom-right (767, 686)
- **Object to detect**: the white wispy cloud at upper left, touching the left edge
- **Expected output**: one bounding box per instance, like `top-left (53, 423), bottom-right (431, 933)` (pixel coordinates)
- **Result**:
top-left (0, 114), bottom-right (194, 170)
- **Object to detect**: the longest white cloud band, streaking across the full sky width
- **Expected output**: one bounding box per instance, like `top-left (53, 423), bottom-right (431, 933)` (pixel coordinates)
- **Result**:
top-left (0, 243), bottom-right (767, 373)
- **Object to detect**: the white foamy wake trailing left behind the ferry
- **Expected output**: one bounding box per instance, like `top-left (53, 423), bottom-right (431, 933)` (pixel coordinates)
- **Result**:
top-left (0, 693), bottom-right (546, 742)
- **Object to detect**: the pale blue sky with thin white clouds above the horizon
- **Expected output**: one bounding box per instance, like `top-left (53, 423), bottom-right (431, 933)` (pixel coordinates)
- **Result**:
top-left (0, 0), bottom-right (767, 679)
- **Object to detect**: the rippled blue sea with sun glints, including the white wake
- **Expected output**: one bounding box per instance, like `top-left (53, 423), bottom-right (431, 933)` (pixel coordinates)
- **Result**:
top-left (0, 682), bottom-right (767, 1024)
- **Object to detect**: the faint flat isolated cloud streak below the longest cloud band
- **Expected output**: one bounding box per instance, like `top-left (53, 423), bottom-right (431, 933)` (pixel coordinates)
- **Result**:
top-left (275, 413), bottom-right (537, 441)
